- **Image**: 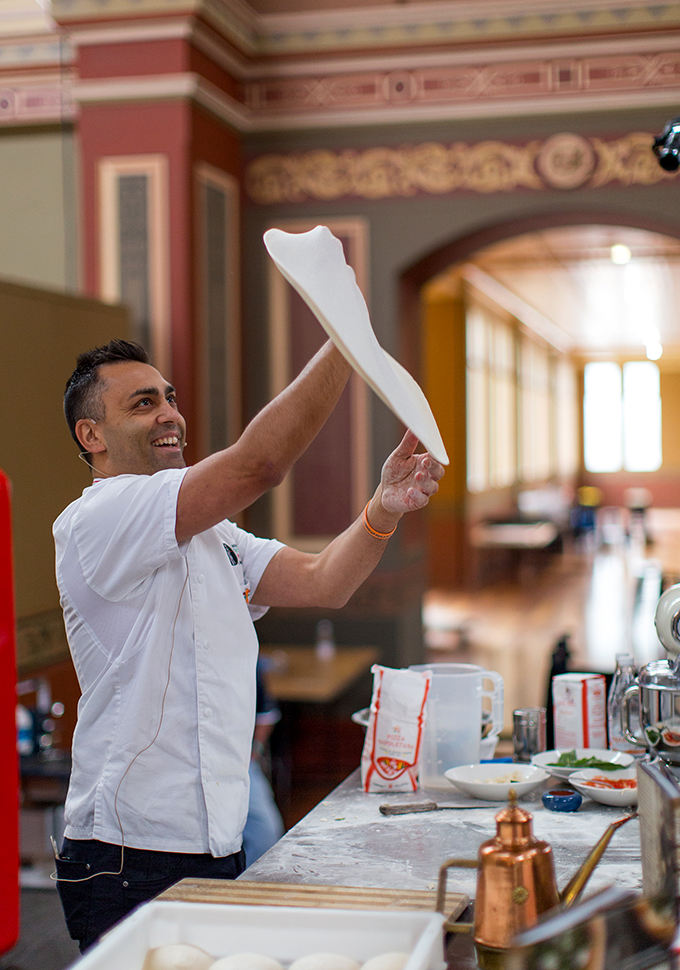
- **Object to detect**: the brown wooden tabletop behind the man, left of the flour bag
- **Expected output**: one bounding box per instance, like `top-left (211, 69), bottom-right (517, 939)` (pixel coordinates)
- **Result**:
top-left (260, 645), bottom-right (378, 704)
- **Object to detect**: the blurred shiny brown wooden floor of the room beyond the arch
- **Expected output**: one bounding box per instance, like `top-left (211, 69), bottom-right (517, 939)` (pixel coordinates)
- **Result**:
top-left (423, 509), bottom-right (680, 732)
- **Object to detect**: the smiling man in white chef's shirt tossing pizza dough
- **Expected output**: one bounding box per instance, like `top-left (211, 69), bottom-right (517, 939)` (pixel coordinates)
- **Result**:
top-left (54, 341), bottom-right (443, 950)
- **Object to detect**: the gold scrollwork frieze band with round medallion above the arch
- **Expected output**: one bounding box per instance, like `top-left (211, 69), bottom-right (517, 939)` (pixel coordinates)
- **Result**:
top-left (246, 132), bottom-right (676, 205)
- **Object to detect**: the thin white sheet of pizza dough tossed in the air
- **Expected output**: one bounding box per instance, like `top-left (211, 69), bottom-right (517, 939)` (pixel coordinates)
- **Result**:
top-left (264, 226), bottom-right (449, 465)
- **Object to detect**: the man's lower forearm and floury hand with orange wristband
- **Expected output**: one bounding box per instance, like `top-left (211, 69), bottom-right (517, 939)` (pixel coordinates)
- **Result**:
top-left (253, 431), bottom-right (444, 608)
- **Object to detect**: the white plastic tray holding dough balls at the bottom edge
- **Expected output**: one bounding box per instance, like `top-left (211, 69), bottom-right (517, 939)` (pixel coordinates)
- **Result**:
top-left (66, 902), bottom-right (445, 970)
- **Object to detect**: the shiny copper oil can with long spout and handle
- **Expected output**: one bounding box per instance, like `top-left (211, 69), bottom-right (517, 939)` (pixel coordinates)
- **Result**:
top-left (437, 789), bottom-right (635, 970)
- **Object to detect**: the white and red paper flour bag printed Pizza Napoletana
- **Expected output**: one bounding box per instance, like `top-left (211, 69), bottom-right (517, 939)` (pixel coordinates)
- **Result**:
top-left (361, 664), bottom-right (432, 792)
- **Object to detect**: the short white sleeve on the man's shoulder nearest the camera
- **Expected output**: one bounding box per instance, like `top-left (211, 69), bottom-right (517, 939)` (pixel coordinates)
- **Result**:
top-left (74, 468), bottom-right (188, 601)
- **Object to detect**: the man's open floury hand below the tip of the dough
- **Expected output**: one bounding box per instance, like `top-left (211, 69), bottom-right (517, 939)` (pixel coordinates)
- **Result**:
top-left (380, 431), bottom-right (444, 515)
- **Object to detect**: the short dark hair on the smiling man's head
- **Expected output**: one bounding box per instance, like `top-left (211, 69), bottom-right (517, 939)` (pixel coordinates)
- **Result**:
top-left (64, 340), bottom-right (150, 448)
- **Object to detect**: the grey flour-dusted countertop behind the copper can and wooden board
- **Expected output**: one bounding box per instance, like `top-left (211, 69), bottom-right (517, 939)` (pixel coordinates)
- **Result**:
top-left (240, 769), bottom-right (642, 898)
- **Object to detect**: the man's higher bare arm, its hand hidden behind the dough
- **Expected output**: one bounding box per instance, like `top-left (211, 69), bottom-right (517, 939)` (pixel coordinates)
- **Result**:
top-left (175, 341), bottom-right (351, 542)
